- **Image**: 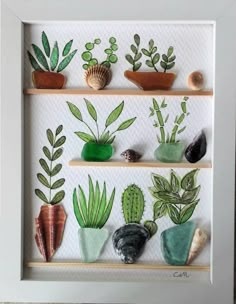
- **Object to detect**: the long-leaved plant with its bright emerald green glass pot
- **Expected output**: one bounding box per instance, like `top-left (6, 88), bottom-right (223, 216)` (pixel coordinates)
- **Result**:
top-left (67, 98), bottom-right (136, 161)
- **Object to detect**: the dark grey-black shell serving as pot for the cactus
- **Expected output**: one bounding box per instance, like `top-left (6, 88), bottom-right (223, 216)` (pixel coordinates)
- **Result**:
top-left (112, 223), bottom-right (150, 264)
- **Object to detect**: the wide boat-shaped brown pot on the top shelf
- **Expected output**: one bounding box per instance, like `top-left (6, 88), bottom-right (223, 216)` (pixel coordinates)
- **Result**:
top-left (124, 71), bottom-right (176, 91)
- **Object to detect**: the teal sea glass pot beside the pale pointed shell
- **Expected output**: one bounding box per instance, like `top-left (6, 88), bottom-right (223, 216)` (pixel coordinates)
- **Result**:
top-left (161, 221), bottom-right (196, 266)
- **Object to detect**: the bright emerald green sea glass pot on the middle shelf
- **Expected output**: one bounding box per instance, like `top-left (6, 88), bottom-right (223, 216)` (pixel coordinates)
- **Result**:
top-left (81, 142), bottom-right (113, 161)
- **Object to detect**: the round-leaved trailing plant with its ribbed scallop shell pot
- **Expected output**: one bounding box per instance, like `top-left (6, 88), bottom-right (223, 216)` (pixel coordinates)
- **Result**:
top-left (81, 37), bottom-right (118, 90)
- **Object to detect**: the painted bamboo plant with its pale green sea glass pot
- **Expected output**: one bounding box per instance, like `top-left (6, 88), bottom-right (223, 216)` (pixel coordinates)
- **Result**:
top-left (149, 97), bottom-right (190, 163)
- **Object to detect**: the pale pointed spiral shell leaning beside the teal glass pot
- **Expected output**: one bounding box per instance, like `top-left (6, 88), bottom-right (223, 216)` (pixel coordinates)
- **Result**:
top-left (186, 228), bottom-right (208, 265)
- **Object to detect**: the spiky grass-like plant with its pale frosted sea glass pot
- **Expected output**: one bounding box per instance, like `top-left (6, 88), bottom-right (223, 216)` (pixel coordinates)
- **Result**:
top-left (73, 176), bottom-right (115, 263)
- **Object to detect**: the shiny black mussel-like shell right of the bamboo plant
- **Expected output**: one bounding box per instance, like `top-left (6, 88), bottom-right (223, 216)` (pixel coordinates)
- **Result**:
top-left (185, 131), bottom-right (207, 163)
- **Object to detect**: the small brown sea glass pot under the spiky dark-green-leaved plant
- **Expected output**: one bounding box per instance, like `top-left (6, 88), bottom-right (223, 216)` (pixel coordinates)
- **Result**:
top-left (32, 71), bottom-right (65, 89)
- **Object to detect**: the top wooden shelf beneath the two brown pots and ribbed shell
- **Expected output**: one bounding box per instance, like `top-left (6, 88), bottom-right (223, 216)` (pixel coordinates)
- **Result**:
top-left (23, 88), bottom-right (213, 96)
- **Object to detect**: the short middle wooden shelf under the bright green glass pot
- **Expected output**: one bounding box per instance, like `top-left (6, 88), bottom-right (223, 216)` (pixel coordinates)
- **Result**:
top-left (69, 160), bottom-right (212, 169)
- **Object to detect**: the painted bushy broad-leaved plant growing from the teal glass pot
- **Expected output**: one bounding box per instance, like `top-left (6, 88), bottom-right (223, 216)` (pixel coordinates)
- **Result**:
top-left (149, 169), bottom-right (201, 224)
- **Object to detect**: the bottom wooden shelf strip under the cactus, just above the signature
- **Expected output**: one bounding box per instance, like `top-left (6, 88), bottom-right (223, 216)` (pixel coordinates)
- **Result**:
top-left (25, 262), bottom-right (210, 272)
